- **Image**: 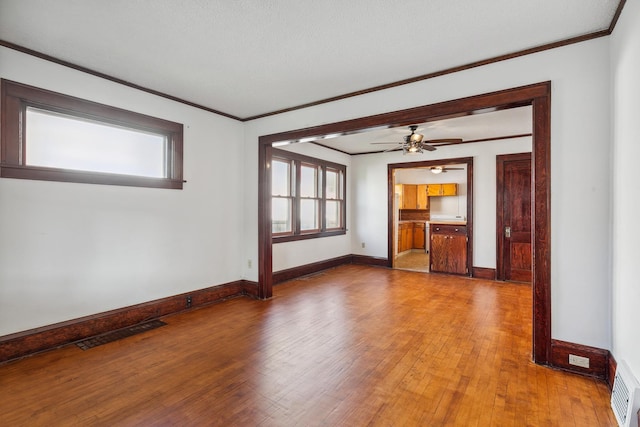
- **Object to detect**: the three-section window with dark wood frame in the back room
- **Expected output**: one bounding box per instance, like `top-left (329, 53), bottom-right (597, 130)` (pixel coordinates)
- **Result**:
top-left (271, 149), bottom-right (346, 242)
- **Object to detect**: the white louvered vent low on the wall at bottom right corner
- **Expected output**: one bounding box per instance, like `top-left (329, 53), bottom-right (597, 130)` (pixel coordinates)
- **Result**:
top-left (611, 361), bottom-right (640, 427)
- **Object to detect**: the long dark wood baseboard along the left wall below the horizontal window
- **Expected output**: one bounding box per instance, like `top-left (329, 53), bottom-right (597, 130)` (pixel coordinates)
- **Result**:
top-left (0, 280), bottom-right (252, 363)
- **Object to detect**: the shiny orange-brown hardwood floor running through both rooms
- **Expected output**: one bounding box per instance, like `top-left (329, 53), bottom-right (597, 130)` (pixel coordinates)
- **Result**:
top-left (0, 265), bottom-right (616, 427)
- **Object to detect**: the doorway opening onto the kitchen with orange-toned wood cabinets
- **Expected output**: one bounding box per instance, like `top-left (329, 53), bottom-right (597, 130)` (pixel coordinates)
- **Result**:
top-left (387, 157), bottom-right (473, 275)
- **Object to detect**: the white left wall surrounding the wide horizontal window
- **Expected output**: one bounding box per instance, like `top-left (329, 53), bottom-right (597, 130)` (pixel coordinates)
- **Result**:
top-left (0, 47), bottom-right (245, 335)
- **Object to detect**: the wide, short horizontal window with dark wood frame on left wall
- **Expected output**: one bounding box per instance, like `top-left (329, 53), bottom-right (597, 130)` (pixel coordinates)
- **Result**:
top-left (0, 80), bottom-right (183, 189)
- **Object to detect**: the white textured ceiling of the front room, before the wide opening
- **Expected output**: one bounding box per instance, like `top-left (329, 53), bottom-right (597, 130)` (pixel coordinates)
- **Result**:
top-left (0, 0), bottom-right (619, 118)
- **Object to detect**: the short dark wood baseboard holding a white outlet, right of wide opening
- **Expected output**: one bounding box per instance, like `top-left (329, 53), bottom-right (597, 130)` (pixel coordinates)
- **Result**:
top-left (551, 340), bottom-right (609, 381)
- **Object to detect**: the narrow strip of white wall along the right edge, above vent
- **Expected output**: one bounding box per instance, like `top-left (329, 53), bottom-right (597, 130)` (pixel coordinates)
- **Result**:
top-left (611, 1), bottom-right (640, 379)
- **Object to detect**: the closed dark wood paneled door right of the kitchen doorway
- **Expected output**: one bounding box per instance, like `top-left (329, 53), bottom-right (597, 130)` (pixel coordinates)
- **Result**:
top-left (496, 153), bottom-right (533, 283)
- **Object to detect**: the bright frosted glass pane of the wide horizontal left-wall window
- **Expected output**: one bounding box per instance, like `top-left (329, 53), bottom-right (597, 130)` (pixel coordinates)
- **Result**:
top-left (25, 107), bottom-right (168, 178)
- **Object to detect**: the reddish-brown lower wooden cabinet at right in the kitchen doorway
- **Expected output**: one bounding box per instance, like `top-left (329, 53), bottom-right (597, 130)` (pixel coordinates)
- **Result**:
top-left (429, 223), bottom-right (469, 274)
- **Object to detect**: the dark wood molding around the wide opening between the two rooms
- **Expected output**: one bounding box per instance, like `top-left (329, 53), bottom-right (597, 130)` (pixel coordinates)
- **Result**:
top-left (258, 81), bottom-right (551, 365)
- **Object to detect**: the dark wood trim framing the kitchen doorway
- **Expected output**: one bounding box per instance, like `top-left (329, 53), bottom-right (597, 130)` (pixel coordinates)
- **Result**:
top-left (387, 157), bottom-right (473, 276)
